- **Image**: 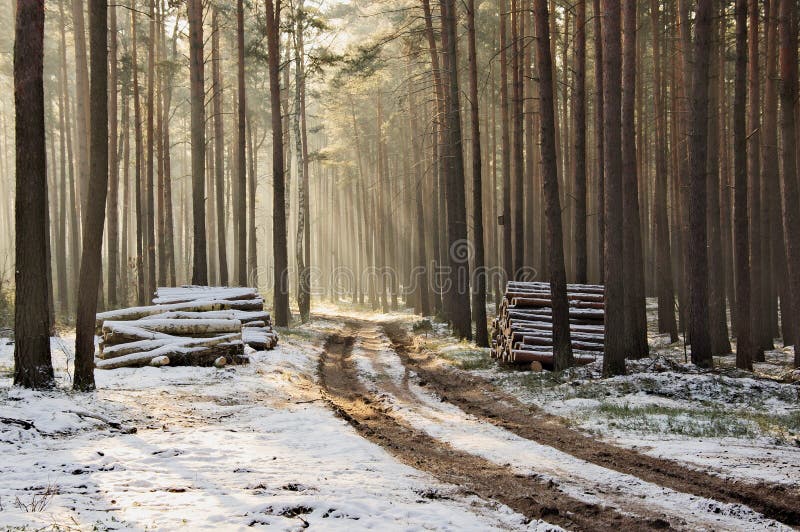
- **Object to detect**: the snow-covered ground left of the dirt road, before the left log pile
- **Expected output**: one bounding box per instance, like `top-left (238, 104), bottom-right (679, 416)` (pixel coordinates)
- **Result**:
top-left (0, 321), bottom-right (535, 530)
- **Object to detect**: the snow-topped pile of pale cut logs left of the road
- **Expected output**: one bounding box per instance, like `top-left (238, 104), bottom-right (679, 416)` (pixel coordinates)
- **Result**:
top-left (95, 286), bottom-right (278, 369)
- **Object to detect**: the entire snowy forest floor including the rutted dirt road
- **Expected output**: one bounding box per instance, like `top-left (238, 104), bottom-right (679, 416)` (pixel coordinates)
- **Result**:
top-left (0, 307), bottom-right (800, 530)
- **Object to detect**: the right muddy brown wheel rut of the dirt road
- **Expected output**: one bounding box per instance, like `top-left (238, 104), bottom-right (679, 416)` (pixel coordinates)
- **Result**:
top-left (383, 322), bottom-right (800, 527)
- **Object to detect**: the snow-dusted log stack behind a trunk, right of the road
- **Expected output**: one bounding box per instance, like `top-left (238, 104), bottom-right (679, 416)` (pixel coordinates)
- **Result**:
top-left (492, 281), bottom-right (605, 367)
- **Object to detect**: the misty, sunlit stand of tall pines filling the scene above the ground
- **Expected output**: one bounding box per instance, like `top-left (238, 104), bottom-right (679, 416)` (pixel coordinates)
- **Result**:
top-left (6, 0), bottom-right (800, 388)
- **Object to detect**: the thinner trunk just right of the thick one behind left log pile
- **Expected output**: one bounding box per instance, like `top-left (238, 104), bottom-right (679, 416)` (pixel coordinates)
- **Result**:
top-left (211, 7), bottom-right (227, 286)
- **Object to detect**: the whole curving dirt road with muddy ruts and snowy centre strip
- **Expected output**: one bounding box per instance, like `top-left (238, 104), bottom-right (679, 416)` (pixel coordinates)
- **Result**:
top-left (319, 318), bottom-right (800, 530)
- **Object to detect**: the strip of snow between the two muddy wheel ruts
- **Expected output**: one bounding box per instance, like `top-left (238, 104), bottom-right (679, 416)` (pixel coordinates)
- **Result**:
top-left (353, 326), bottom-right (790, 531)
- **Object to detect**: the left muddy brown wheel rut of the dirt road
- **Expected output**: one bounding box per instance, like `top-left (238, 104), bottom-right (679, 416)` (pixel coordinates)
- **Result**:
top-left (319, 325), bottom-right (670, 531)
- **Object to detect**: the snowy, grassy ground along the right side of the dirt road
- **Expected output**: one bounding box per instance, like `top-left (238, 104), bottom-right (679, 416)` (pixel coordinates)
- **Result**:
top-left (417, 300), bottom-right (800, 487)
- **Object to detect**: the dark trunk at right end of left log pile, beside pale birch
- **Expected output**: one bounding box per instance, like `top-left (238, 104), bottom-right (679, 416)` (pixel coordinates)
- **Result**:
top-left (266, 0), bottom-right (290, 327)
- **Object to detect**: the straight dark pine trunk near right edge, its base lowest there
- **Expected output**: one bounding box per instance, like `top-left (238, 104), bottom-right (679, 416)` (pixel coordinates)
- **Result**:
top-left (733, 0), bottom-right (756, 370)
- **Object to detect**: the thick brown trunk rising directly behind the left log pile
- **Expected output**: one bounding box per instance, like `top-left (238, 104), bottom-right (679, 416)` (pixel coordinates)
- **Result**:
top-left (187, 0), bottom-right (206, 285)
